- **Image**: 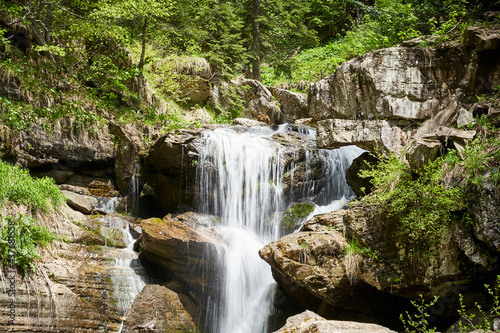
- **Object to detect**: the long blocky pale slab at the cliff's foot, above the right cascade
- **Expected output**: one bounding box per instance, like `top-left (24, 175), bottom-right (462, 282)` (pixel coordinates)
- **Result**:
top-left (317, 119), bottom-right (410, 152)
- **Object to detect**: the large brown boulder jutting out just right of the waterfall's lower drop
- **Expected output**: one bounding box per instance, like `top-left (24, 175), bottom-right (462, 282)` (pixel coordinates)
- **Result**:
top-left (259, 227), bottom-right (400, 312)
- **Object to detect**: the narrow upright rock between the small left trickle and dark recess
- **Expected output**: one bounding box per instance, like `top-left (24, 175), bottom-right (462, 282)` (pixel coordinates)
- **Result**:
top-left (108, 122), bottom-right (143, 196)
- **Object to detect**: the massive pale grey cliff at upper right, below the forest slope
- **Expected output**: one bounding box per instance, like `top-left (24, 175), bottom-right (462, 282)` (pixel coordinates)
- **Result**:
top-left (308, 28), bottom-right (500, 151)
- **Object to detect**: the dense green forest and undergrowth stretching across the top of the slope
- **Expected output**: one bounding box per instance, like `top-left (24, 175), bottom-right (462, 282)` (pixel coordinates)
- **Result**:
top-left (0, 0), bottom-right (498, 128)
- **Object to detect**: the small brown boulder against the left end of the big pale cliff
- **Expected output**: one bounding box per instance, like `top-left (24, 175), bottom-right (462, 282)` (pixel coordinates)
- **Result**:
top-left (268, 87), bottom-right (309, 124)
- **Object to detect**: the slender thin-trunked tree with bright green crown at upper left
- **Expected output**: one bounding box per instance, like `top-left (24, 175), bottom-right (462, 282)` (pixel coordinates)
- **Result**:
top-left (93, 0), bottom-right (175, 108)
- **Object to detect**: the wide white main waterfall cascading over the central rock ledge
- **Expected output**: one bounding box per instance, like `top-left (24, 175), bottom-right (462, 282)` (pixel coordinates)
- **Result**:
top-left (197, 126), bottom-right (362, 333)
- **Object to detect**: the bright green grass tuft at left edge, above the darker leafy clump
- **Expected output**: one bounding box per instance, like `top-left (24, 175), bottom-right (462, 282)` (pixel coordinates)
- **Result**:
top-left (0, 160), bottom-right (65, 213)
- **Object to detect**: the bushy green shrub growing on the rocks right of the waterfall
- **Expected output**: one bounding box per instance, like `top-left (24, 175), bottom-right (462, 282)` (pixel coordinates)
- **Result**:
top-left (360, 153), bottom-right (464, 257)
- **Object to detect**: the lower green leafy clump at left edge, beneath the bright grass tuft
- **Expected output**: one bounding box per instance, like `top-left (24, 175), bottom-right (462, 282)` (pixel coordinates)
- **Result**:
top-left (0, 214), bottom-right (57, 276)
